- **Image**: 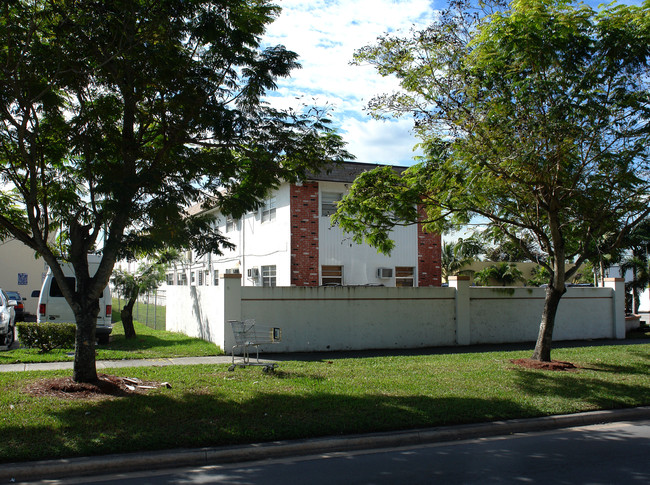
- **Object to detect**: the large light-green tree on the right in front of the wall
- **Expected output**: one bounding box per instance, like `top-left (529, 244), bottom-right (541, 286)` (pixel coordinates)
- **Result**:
top-left (336, 0), bottom-right (650, 361)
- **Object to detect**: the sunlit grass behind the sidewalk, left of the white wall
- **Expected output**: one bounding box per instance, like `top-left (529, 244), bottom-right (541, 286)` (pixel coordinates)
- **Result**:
top-left (0, 322), bottom-right (223, 364)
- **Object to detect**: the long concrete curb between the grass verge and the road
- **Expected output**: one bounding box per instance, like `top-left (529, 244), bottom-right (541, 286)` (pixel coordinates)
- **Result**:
top-left (0, 406), bottom-right (650, 482)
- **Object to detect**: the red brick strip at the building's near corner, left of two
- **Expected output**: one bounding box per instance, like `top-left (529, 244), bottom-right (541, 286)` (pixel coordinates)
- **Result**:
top-left (289, 182), bottom-right (319, 286)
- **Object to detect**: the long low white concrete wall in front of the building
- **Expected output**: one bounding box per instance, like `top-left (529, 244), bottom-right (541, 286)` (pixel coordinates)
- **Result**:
top-left (167, 274), bottom-right (625, 352)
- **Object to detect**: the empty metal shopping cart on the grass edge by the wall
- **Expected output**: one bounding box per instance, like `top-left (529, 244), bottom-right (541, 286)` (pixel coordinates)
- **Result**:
top-left (228, 320), bottom-right (282, 372)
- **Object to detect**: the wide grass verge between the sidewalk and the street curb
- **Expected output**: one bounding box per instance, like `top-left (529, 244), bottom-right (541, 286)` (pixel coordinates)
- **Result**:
top-left (0, 342), bottom-right (650, 462)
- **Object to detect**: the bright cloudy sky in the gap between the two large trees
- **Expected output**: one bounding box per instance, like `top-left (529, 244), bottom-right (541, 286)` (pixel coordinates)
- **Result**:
top-left (265, 0), bottom-right (641, 165)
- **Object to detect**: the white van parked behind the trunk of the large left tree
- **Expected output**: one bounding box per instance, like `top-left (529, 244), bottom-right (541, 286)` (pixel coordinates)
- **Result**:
top-left (37, 256), bottom-right (113, 344)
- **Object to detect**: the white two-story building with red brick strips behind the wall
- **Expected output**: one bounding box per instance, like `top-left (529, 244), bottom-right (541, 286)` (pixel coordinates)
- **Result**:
top-left (167, 162), bottom-right (441, 286)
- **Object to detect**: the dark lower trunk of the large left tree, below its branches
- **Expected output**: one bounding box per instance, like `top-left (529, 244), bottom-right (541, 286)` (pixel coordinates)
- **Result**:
top-left (72, 300), bottom-right (99, 382)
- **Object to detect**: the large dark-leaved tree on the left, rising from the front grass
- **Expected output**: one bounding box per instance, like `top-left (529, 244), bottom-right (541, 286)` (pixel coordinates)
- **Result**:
top-left (0, 0), bottom-right (349, 382)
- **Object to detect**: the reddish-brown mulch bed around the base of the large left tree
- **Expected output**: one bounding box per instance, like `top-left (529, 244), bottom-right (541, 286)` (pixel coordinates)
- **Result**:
top-left (25, 374), bottom-right (160, 401)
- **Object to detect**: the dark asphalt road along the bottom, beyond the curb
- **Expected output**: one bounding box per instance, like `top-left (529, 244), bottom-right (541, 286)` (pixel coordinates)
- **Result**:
top-left (20, 420), bottom-right (650, 485)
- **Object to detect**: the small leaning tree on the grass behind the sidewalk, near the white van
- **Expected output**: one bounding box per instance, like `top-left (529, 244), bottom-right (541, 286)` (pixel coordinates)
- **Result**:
top-left (111, 251), bottom-right (179, 339)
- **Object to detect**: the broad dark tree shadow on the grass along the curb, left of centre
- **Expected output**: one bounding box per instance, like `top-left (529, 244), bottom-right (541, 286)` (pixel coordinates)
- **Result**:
top-left (0, 390), bottom-right (536, 462)
